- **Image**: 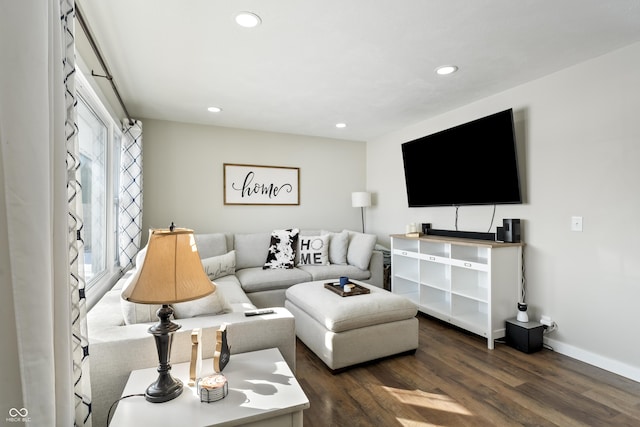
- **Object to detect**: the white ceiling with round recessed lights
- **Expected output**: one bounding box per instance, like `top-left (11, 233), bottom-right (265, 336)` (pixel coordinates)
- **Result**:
top-left (76, 0), bottom-right (640, 141)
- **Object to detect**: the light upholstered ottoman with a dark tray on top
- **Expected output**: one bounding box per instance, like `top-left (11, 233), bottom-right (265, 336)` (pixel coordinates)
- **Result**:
top-left (285, 280), bottom-right (418, 371)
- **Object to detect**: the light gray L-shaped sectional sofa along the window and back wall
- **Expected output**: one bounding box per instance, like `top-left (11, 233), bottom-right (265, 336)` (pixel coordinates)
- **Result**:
top-left (87, 231), bottom-right (383, 425)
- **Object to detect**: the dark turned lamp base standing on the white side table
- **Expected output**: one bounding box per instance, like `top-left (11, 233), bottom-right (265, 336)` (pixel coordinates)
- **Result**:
top-left (145, 304), bottom-right (182, 403)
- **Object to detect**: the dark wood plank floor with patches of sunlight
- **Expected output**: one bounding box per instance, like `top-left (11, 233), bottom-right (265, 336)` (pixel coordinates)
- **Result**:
top-left (296, 315), bottom-right (640, 427)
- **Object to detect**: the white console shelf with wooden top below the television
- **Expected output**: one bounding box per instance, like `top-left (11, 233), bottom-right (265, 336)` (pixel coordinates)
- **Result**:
top-left (391, 234), bottom-right (524, 349)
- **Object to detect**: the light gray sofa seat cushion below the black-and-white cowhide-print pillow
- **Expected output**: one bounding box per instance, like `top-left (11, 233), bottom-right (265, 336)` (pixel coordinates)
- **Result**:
top-left (236, 267), bottom-right (311, 292)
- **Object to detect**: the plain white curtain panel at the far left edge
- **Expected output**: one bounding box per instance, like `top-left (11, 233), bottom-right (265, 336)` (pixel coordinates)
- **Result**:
top-left (0, 0), bottom-right (91, 426)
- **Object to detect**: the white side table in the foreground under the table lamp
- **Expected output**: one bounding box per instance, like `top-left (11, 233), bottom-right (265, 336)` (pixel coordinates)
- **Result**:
top-left (110, 348), bottom-right (309, 427)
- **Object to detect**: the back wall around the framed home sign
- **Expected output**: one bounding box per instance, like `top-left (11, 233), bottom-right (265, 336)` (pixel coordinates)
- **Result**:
top-left (143, 120), bottom-right (366, 241)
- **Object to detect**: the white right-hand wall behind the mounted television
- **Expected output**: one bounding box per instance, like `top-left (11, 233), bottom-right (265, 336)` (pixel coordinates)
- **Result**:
top-left (367, 44), bottom-right (640, 380)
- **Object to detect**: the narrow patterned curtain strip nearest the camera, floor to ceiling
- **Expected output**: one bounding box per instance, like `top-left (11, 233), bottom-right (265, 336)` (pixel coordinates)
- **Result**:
top-left (60, 0), bottom-right (91, 426)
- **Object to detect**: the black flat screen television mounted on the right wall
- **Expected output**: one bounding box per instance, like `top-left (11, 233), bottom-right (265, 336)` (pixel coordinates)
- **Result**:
top-left (402, 109), bottom-right (522, 207)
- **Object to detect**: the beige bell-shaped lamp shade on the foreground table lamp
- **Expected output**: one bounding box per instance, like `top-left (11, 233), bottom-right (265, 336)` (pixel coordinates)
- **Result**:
top-left (122, 228), bottom-right (216, 304)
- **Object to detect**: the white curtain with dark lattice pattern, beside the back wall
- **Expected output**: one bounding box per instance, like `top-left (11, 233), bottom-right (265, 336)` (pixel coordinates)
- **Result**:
top-left (118, 119), bottom-right (142, 271)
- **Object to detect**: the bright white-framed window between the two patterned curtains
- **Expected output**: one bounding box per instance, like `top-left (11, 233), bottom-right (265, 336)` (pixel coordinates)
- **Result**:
top-left (76, 72), bottom-right (122, 306)
